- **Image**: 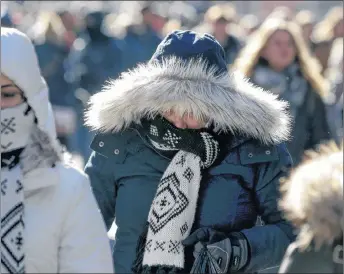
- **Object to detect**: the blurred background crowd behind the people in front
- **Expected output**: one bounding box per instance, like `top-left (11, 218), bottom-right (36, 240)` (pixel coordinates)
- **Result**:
top-left (1, 1), bottom-right (344, 166)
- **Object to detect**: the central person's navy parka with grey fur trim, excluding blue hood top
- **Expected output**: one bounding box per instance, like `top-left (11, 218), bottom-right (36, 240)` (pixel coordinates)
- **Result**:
top-left (85, 58), bottom-right (293, 273)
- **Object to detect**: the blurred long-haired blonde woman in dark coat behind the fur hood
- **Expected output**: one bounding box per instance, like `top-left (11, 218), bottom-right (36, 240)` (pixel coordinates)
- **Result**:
top-left (233, 18), bottom-right (331, 165)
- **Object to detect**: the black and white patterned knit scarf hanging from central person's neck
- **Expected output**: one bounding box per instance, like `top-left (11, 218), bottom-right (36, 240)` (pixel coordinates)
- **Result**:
top-left (133, 117), bottom-right (220, 273)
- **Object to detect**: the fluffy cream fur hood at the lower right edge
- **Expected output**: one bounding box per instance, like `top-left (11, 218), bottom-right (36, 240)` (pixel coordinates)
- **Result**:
top-left (279, 142), bottom-right (344, 250)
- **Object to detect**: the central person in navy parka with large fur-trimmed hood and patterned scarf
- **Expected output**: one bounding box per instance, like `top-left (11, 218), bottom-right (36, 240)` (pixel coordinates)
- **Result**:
top-left (86, 31), bottom-right (293, 273)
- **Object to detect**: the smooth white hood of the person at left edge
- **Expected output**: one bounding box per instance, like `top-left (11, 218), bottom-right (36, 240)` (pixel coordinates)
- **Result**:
top-left (1, 27), bottom-right (62, 158)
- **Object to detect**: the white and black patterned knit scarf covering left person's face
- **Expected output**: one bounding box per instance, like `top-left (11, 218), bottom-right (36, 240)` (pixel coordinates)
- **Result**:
top-left (1, 103), bottom-right (34, 273)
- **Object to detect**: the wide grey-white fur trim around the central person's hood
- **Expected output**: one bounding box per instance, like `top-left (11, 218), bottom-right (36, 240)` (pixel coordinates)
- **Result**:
top-left (86, 57), bottom-right (290, 144)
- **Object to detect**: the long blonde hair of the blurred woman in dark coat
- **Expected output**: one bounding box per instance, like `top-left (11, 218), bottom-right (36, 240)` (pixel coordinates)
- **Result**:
top-left (232, 18), bottom-right (329, 97)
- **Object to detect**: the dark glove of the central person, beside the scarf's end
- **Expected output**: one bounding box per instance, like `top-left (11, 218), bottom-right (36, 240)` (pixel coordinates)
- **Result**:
top-left (182, 228), bottom-right (249, 273)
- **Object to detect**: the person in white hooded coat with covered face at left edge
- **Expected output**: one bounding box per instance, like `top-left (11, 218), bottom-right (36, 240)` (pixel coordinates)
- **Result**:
top-left (0, 27), bottom-right (113, 273)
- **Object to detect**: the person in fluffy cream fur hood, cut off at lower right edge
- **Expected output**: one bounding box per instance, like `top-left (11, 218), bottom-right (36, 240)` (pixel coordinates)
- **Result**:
top-left (278, 142), bottom-right (344, 274)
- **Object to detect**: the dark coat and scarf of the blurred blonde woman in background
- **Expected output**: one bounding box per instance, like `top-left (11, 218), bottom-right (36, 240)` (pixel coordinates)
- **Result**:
top-left (251, 61), bottom-right (330, 166)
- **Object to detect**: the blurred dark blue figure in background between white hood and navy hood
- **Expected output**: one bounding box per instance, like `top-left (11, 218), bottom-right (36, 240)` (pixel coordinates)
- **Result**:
top-left (66, 11), bottom-right (122, 100)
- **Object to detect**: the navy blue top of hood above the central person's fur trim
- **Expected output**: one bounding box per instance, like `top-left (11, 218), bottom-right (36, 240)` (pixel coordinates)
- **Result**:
top-left (151, 30), bottom-right (228, 74)
